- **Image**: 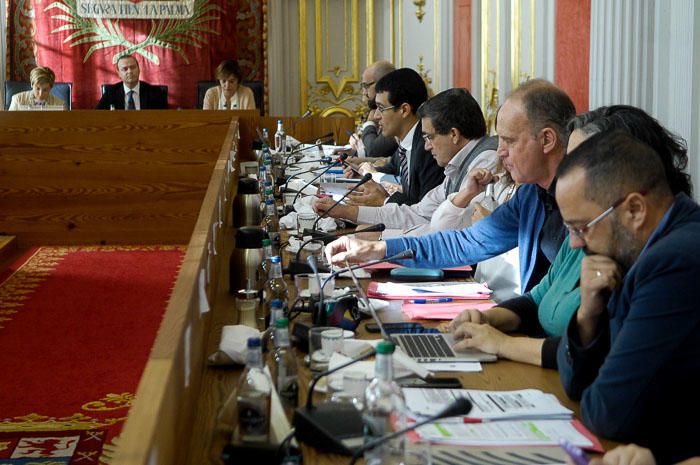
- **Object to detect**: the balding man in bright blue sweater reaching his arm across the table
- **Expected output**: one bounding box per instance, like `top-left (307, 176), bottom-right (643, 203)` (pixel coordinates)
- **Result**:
top-left (326, 80), bottom-right (575, 292)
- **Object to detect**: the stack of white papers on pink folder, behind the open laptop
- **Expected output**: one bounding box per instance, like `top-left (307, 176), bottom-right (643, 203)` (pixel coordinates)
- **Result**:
top-left (367, 281), bottom-right (491, 300)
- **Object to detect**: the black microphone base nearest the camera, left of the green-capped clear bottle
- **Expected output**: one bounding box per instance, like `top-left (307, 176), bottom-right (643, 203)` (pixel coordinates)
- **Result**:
top-left (293, 402), bottom-right (364, 455)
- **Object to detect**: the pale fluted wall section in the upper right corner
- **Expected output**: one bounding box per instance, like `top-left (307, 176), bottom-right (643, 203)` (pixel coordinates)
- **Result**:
top-left (589, 0), bottom-right (700, 200)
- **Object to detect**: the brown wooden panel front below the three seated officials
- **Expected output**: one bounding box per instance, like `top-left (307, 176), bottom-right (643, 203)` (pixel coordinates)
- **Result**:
top-left (0, 110), bottom-right (231, 247)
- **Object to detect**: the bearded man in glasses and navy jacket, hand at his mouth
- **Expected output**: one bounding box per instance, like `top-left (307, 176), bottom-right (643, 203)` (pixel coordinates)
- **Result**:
top-left (556, 131), bottom-right (700, 463)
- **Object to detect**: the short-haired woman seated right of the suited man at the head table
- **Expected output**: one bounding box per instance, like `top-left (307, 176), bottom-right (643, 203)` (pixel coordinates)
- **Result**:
top-left (202, 60), bottom-right (255, 110)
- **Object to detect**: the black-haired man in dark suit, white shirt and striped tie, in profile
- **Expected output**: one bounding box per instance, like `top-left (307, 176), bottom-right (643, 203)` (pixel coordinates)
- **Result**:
top-left (338, 68), bottom-right (445, 205)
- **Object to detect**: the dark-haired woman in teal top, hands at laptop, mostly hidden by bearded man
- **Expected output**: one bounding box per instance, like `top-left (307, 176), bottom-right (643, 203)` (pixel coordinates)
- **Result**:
top-left (450, 105), bottom-right (692, 368)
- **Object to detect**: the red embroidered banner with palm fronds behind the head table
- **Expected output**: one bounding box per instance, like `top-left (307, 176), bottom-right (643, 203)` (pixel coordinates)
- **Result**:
top-left (8, 0), bottom-right (267, 109)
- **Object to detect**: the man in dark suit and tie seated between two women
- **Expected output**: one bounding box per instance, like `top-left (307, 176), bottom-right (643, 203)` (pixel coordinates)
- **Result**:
top-left (97, 55), bottom-right (168, 110)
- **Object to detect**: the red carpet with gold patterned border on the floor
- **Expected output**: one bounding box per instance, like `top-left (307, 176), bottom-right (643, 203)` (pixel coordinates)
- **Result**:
top-left (0, 246), bottom-right (185, 465)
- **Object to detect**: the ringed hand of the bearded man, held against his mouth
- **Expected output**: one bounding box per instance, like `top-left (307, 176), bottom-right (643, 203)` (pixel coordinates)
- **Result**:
top-left (576, 255), bottom-right (622, 346)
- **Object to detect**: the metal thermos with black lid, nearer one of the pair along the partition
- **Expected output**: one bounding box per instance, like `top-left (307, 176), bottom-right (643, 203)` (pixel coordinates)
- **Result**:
top-left (228, 227), bottom-right (265, 294)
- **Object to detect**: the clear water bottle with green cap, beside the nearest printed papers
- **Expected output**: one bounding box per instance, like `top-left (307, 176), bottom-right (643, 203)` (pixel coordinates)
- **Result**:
top-left (362, 341), bottom-right (406, 465)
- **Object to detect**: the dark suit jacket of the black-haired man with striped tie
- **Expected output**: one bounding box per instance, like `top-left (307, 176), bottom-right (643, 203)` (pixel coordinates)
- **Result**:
top-left (377, 121), bottom-right (445, 205)
